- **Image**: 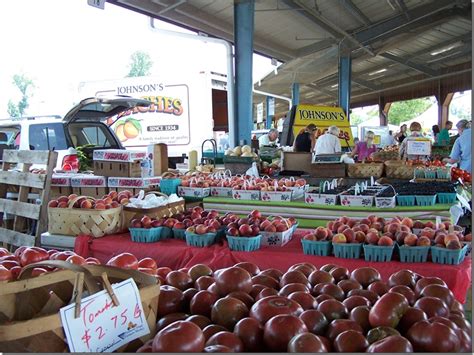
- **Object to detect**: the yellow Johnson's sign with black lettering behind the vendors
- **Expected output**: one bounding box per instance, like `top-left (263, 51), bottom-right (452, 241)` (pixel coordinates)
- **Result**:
top-left (293, 105), bottom-right (354, 147)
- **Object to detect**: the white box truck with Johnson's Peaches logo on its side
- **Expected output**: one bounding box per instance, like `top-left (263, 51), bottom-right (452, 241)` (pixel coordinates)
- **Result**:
top-left (78, 71), bottom-right (229, 166)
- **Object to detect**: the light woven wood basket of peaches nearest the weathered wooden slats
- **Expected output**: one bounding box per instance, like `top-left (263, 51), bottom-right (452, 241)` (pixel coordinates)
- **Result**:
top-left (48, 196), bottom-right (122, 238)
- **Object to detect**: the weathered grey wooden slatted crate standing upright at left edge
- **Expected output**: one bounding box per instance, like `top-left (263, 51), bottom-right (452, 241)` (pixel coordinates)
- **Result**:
top-left (0, 150), bottom-right (58, 249)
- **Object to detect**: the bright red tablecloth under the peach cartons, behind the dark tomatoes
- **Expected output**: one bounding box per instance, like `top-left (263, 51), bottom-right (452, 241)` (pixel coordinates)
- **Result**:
top-left (74, 230), bottom-right (471, 303)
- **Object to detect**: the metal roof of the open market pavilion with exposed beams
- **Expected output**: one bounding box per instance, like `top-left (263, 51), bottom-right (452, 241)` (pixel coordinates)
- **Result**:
top-left (108, 0), bottom-right (472, 112)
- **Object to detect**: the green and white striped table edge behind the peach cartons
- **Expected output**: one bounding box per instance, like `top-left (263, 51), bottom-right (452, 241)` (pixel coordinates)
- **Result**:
top-left (203, 197), bottom-right (452, 228)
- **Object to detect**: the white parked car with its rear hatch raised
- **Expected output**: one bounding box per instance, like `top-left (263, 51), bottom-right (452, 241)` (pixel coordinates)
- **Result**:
top-left (0, 96), bottom-right (151, 170)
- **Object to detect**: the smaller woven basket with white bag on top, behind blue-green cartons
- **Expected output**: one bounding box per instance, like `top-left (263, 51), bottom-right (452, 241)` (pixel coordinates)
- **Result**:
top-left (121, 191), bottom-right (185, 231)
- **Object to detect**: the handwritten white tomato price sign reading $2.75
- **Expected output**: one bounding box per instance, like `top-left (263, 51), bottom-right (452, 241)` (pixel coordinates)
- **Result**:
top-left (60, 279), bottom-right (150, 352)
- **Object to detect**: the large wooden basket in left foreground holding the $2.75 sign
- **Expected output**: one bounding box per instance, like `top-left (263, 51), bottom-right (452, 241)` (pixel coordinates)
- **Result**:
top-left (0, 260), bottom-right (160, 353)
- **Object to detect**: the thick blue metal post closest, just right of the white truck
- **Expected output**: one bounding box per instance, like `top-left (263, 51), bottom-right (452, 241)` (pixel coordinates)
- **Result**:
top-left (231, 0), bottom-right (255, 144)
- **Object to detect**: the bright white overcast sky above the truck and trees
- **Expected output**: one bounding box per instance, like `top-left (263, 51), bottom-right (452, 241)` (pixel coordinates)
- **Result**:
top-left (0, 0), bottom-right (274, 118)
